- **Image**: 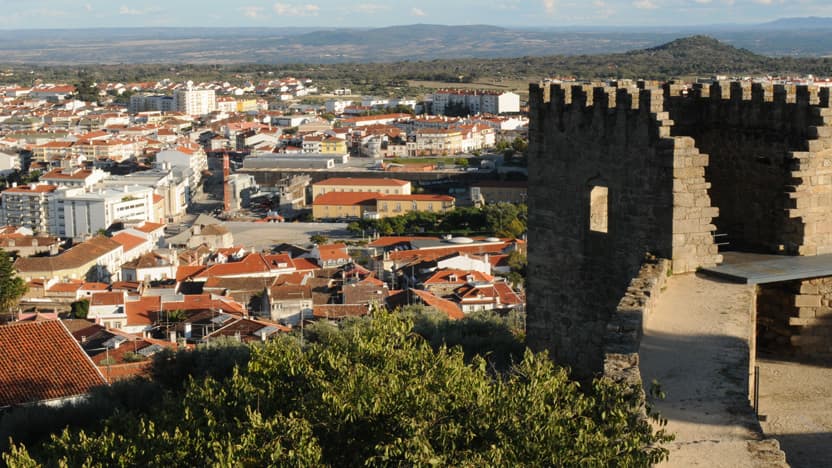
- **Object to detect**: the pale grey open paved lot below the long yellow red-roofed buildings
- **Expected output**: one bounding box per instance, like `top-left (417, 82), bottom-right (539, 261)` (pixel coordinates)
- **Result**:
top-left (223, 222), bottom-right (352, 250)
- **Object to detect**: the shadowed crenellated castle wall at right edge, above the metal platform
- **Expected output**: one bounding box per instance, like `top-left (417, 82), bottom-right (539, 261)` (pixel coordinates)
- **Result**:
top-left (665, 82), bottom-right (832, 255)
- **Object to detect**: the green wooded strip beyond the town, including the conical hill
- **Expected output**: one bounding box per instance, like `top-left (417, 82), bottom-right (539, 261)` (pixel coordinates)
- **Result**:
top-left (0, 36), bottom-right (832, 95)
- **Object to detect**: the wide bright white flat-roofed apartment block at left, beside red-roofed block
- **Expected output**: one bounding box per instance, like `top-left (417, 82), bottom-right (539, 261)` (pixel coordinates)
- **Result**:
top-left (50, 185), bottom-right (156, 238)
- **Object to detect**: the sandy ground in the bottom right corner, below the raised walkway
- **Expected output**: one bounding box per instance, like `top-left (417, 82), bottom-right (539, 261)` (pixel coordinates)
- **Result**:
top-left (757, 359), bottom-right (832, 468)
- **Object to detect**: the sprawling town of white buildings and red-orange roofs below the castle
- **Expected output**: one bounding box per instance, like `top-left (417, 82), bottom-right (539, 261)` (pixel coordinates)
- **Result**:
top-left (0, 73), bottom-right (528, 394)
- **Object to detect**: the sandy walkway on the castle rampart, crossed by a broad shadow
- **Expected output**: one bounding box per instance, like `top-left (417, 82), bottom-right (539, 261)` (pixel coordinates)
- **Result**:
top-left (639, 275), bottom-right (776, 467)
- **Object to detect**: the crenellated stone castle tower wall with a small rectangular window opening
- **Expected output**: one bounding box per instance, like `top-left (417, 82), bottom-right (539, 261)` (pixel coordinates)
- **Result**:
top-left (527, 85), bottom-right (719, 377)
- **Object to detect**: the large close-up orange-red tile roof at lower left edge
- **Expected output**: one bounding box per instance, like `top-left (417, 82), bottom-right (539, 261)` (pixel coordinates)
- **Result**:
top-left (0, 320), bottom-right (107, 408)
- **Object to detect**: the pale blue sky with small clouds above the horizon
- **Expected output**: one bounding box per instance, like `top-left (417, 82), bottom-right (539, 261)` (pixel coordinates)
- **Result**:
top-left (0, 0), bottom-right (832, 29)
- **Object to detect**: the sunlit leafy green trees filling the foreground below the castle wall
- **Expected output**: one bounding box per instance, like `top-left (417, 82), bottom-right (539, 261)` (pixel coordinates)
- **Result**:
top-left (0, 311), bottom-right (670, 466)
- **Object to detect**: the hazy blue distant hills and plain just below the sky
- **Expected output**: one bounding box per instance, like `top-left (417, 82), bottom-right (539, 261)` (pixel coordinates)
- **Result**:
top-left (0, 18), bottom-right (832, 64)
